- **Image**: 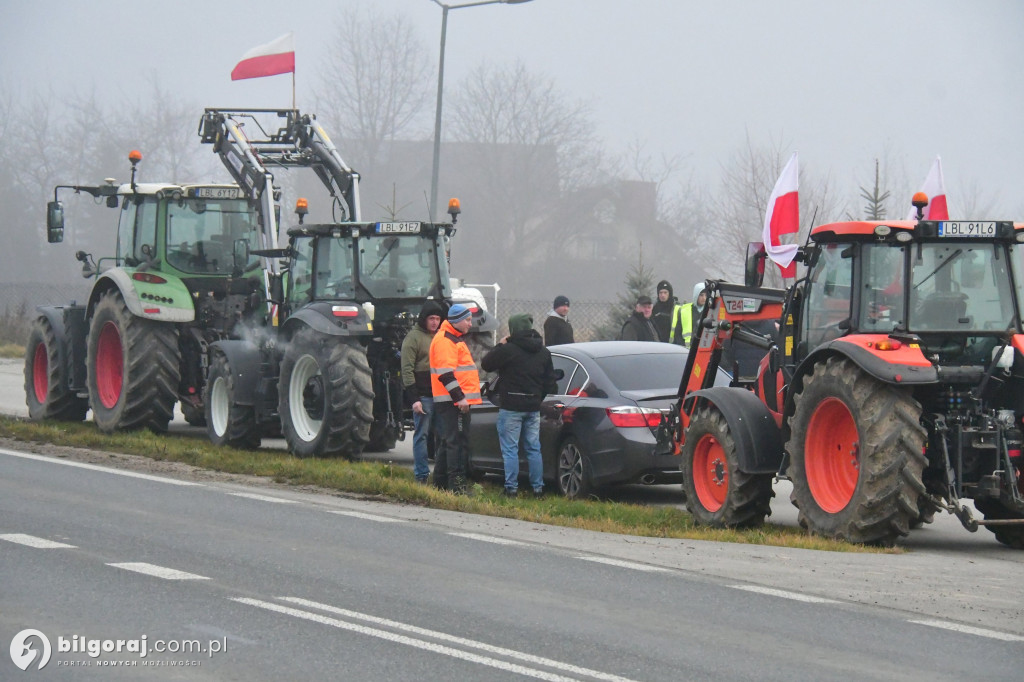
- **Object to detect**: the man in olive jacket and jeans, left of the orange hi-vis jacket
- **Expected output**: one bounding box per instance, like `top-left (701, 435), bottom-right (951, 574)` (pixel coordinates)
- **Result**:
top-left (401, 300), bottom-right (444, 483)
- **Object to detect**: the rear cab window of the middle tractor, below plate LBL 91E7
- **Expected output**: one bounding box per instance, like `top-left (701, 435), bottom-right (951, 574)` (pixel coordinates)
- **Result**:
top-left (359, 235), bottom-right (447, 298)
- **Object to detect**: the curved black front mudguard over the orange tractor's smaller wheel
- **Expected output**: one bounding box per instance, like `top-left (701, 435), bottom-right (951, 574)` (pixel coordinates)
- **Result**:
top-left (686, 386), bottom-right (782, 474)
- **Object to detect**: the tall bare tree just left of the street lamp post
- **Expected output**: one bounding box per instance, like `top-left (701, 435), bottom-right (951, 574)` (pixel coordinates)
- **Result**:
top-left (313, 7), bottom-right (435, 173)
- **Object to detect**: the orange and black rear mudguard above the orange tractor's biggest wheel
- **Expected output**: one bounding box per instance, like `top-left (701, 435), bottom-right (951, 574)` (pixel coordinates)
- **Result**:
top-left (797, 334), bottom-right (939, 386)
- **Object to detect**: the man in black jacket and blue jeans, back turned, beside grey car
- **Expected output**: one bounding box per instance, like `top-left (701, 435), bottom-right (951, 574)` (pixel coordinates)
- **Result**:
top-left (480, 313), bottom-right (558, 498)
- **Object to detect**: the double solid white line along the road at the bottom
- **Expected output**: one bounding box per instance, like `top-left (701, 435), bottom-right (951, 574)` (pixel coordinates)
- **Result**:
top-left (231, 597), bottom-right (632, 682)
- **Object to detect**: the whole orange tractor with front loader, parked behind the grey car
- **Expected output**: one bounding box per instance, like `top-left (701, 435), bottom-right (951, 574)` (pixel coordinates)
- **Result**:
top-left (660, 198), bottom-right (1024, 549)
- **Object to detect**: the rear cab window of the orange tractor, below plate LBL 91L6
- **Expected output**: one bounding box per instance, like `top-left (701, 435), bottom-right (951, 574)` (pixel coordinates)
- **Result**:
top-left (907, 242), bottom-right (1015, 332)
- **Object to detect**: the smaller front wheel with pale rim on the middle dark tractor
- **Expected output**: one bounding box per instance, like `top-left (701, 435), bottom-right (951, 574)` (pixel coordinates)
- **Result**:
top-left (203, 352), bottom-right (262, 450)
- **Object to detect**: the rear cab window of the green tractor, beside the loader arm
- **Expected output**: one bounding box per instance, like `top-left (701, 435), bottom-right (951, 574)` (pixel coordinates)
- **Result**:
top-left (167, 199), bottom-right (260, 274)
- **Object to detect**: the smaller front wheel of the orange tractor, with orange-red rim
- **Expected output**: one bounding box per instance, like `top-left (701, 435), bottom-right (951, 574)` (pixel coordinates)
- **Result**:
top-left (679, 407), bottom-right (775, 528)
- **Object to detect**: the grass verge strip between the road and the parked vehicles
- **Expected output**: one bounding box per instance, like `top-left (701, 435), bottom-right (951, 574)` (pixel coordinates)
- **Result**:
top-left (0, 416), bottom-right (884, 552)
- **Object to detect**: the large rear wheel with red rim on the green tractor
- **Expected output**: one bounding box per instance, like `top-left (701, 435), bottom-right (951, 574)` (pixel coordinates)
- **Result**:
top-left (87, 289), bottom-right (180, 433)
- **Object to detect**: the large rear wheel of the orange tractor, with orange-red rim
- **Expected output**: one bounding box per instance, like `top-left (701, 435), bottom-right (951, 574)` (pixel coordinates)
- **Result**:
top-left (786, 357), bottom-right (927, 545)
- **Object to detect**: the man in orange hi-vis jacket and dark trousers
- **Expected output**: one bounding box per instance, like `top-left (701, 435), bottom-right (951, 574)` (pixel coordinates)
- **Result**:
top-left (430, 303), bottom-right (480, 495)
